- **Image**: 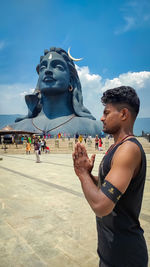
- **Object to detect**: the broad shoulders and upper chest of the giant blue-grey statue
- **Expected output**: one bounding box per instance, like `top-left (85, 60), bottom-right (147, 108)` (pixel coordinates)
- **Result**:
top-left (11, 114), bottom-right (102, 136)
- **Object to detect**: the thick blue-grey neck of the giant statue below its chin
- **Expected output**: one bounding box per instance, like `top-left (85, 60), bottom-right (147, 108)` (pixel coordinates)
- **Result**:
top-left (42, 92), bottom-right (74, 119)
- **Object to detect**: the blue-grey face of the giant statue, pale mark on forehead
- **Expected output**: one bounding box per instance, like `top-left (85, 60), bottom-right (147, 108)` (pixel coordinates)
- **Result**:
top-left (38, 52), bottom-right (70, 94)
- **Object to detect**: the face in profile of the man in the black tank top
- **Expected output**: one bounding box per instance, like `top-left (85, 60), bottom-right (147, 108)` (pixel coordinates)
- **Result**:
top-left (101, 104), bottom-right (121, 134)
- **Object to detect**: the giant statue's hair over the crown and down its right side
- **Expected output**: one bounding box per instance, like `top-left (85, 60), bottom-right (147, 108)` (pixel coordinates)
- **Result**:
top-left (35, 47), bottom-right (95, 120)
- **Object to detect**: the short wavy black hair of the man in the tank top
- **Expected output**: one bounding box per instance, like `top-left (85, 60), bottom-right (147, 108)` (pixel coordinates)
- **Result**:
top-left (101, 86), bottom-right (140, 118)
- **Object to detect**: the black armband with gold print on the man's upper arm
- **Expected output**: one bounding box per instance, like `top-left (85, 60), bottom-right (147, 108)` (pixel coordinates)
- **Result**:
top-left (101, 180), bottom-right (122, 204)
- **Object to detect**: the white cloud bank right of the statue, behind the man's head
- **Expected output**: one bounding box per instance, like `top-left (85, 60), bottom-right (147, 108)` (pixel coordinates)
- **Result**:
top-left (77, 66), bottom-right (150, 119)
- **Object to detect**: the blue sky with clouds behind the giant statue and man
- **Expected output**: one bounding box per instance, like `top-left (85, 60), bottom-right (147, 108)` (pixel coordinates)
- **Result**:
top-left (0, 0), bottom-right (150, 119)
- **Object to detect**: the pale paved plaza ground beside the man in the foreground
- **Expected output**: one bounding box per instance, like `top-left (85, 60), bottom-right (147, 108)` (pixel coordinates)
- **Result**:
top-left (0, 153), bottom-right (150, 267)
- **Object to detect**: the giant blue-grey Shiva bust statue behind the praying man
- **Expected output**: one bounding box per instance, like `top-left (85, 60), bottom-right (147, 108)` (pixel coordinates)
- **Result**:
top-left (11, 47), bottom-right (102, 136)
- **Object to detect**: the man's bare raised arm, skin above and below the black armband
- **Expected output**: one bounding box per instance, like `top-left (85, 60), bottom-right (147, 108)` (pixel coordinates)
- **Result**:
top-left (73, 142), bottom-right (141, 217)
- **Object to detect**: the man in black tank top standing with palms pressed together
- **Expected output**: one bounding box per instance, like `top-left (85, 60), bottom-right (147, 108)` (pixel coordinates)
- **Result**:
top-left (73, 86), bottom-right (148, 267)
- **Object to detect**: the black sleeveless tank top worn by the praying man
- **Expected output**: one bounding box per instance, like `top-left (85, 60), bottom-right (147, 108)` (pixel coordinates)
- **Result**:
top-left (96, 138), bottom-right (148, 267)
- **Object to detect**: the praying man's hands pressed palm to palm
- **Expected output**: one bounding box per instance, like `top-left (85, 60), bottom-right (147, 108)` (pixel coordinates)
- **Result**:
top-left (72, 143), bottom-right (95, 178)
